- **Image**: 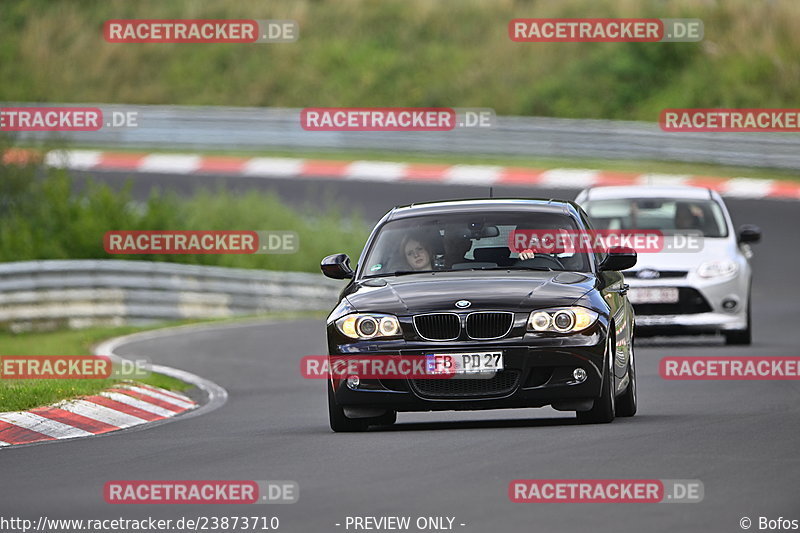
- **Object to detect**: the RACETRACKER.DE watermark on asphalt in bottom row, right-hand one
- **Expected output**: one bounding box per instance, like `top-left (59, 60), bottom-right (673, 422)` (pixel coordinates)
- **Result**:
top-left (508, 479), bottom-right (705, 503)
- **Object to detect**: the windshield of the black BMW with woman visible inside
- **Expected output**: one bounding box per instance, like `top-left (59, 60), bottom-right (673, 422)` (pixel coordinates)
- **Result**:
top-left (363, 212), bottom-right (590, 277)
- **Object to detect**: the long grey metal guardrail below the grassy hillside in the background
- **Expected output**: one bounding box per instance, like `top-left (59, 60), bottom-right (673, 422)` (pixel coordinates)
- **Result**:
top-left (6, 103), bottom-right (800, 170)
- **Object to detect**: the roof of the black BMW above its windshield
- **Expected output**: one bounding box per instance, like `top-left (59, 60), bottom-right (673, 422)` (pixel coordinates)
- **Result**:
top-left (387, 198), bottom-right (579, 220)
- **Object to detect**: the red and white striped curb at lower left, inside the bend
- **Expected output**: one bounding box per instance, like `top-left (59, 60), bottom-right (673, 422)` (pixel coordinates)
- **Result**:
top-left (0, 383), bottom-right (197, 446)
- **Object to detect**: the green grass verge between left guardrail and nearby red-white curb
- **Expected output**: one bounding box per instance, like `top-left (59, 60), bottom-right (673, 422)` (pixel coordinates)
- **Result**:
top-left (0, 312), bottom-right (323, 412)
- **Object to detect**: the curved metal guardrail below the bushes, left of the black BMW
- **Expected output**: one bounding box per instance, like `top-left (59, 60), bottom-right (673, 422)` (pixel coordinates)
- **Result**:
top-left (0, 259), bottom-right (343, 331)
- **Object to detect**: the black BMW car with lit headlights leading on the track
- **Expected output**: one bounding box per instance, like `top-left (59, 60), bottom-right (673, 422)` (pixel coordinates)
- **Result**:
top-left (321, 199), bottom-right (636, 432)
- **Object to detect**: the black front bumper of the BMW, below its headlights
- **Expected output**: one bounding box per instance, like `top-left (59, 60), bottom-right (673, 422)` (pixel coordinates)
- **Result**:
top-left (329, 324), bottom-right (607, 417)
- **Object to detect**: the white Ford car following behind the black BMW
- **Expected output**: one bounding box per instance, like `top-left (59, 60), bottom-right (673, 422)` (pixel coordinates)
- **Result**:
top-left (575, 186), bottom-right (761, 344)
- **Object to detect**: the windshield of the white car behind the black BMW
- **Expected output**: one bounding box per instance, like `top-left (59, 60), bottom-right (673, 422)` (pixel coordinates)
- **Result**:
top-left (583, 198), bottom-right (728, 238)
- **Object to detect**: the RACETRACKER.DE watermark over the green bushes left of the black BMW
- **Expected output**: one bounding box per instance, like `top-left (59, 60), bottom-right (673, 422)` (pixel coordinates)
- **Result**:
top-left (103, 230), bottom-right (300, 254)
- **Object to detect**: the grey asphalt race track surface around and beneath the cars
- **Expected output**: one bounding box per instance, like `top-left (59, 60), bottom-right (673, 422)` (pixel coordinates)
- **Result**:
top-left (0, 174), bottom-right (800, 533)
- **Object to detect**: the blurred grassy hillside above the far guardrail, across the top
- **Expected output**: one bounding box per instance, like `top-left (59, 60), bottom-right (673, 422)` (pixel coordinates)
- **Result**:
top-left (0, 0), bottom-right (800, 121)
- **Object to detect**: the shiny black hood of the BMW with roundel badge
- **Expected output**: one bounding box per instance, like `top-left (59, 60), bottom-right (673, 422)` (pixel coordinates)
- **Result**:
top-left (346, 270), bottom-right (595, 315)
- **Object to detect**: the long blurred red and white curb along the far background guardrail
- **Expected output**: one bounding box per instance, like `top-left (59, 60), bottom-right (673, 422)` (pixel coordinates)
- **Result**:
top-left (12, 150), bottom-right (800, 200)
